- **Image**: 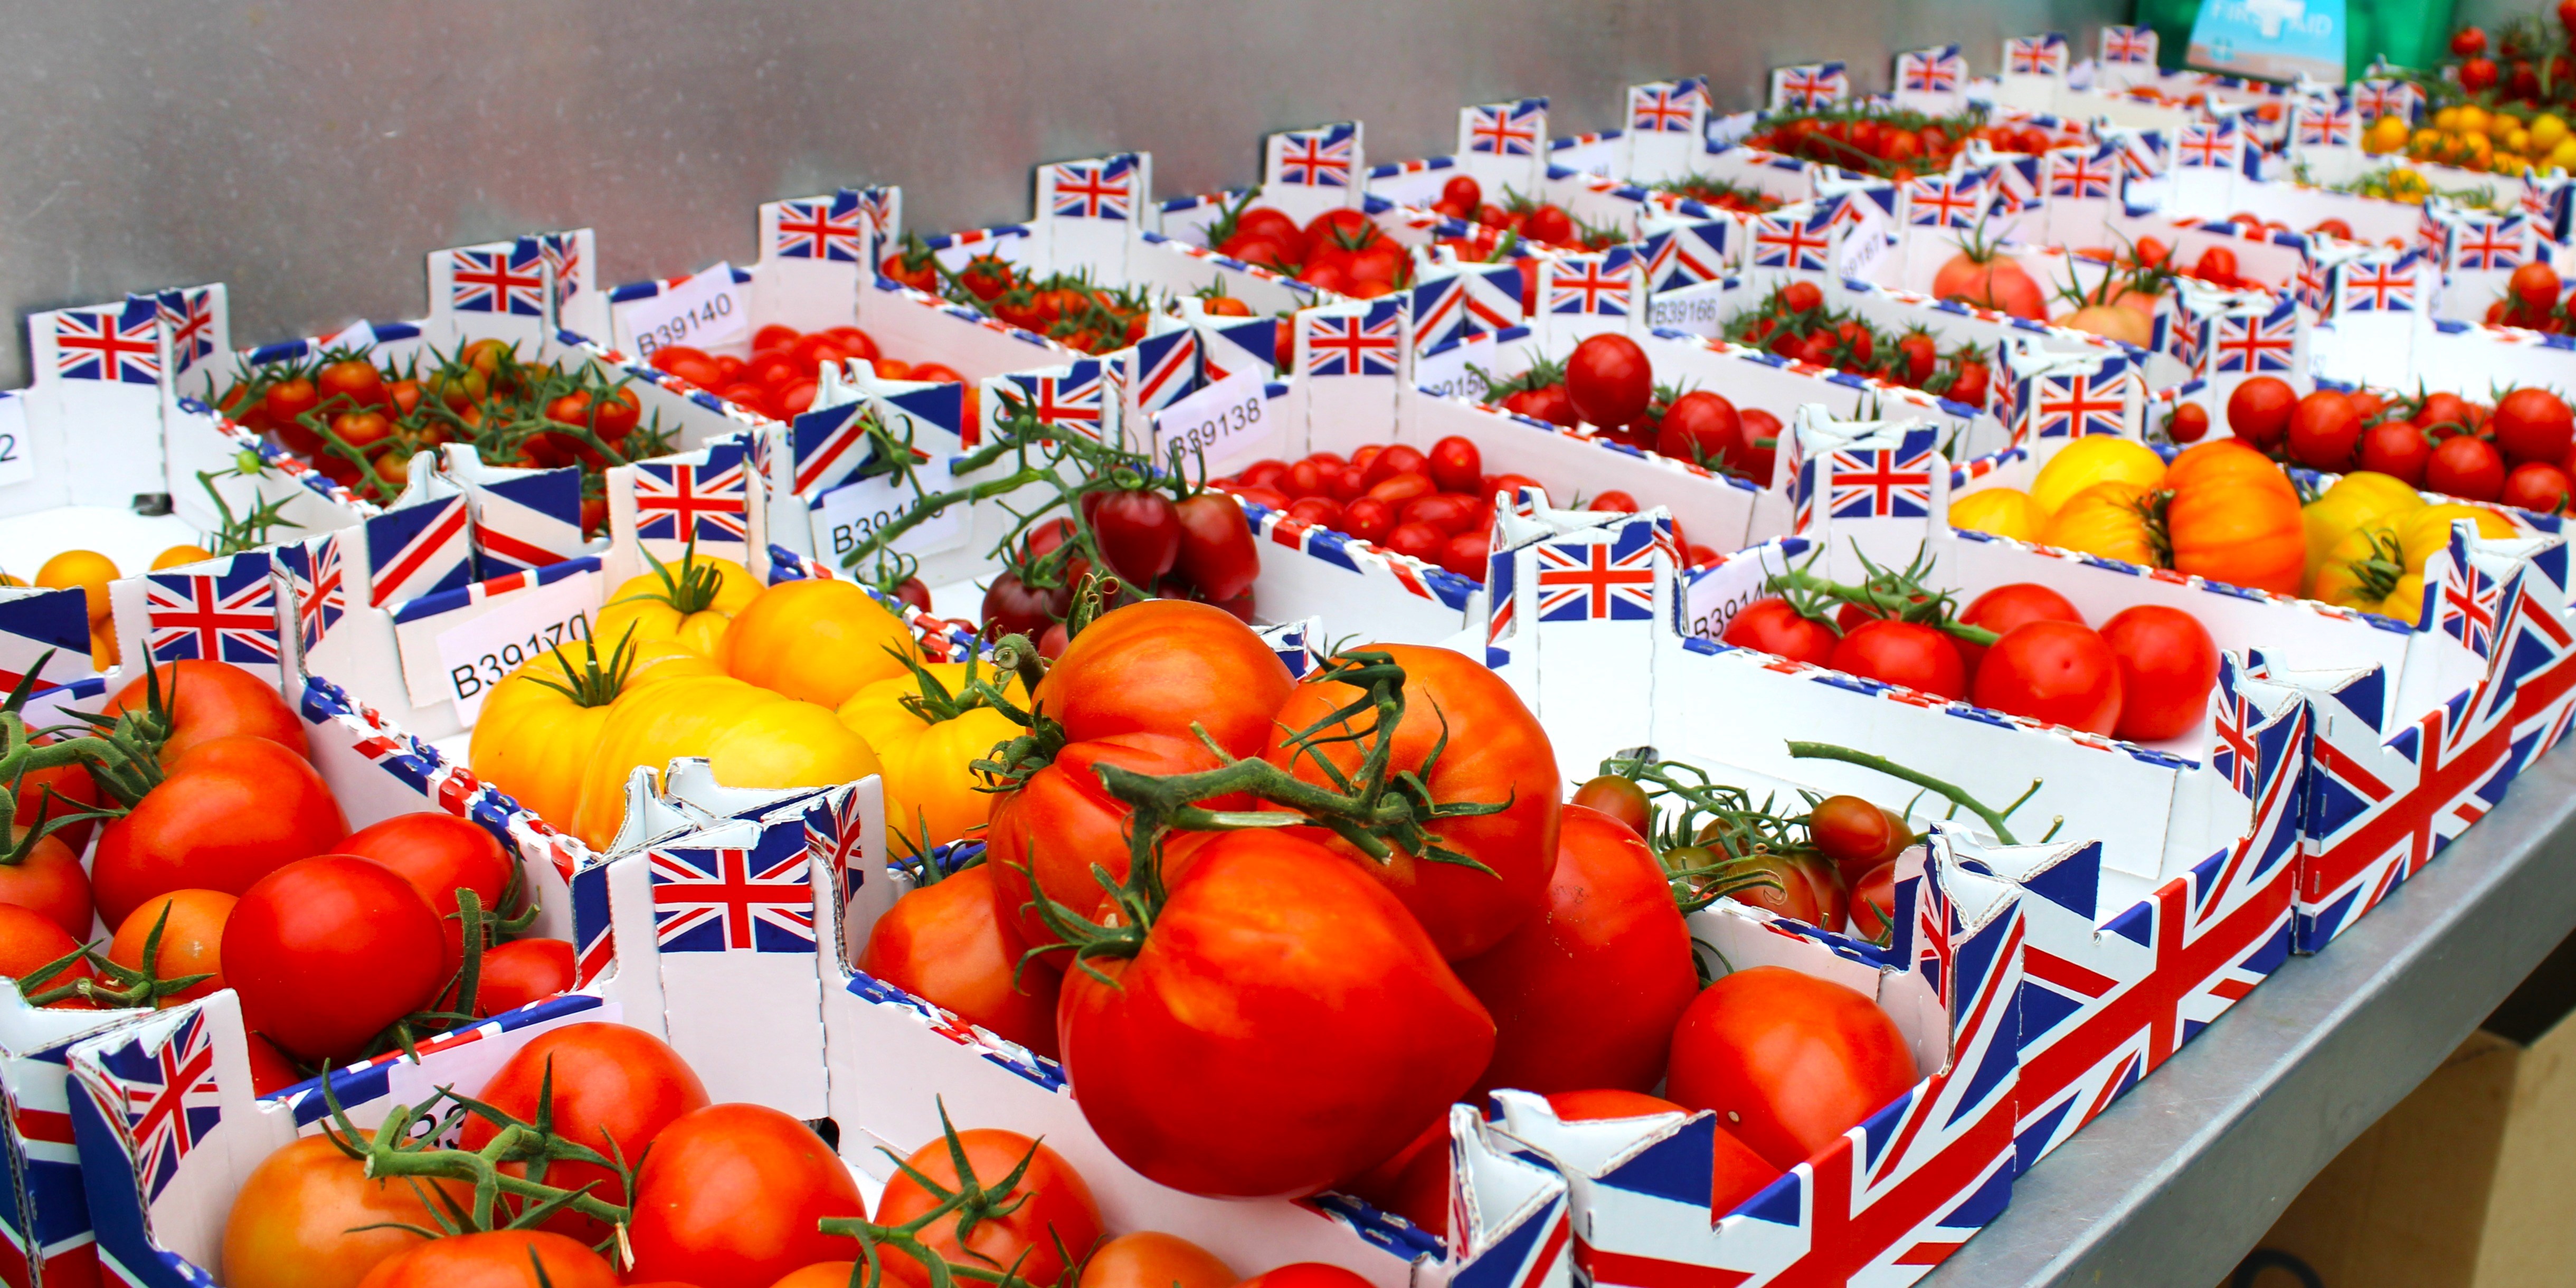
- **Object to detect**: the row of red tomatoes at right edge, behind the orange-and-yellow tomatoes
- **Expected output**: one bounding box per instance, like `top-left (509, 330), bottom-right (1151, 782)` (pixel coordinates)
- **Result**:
top-left (2215, 376), bottom-right (2576, 513)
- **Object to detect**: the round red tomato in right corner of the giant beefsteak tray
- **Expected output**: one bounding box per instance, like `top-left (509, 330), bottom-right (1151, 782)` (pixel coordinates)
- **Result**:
top-left (1664, 966), bottom-right (1914, 1170)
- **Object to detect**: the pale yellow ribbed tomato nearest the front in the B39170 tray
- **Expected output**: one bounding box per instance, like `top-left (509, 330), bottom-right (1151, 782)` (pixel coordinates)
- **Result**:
top-left (572, 675), bottom-right (878, 850)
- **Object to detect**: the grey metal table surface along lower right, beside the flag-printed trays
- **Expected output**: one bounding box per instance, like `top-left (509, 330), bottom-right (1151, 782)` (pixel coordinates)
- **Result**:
top-left (1921, 747), bottom-right (2576, 1288)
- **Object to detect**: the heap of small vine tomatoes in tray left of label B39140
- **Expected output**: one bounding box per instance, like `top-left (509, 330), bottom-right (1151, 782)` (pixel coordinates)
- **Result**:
top-left (216, 340), bottom-right (670, 531)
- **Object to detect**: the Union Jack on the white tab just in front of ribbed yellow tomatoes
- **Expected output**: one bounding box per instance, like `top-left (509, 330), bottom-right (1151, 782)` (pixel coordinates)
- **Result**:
top-left (649, 829), bottom-right (814, 953)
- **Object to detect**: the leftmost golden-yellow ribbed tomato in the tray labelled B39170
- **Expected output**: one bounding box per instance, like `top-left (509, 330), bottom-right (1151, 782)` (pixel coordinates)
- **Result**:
top-left (466, 639), bottom-right (721, 829)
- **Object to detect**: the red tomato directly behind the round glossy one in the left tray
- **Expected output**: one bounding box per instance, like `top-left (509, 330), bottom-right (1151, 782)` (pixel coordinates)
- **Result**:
top-left (90, 734), bottom-right (350, 932)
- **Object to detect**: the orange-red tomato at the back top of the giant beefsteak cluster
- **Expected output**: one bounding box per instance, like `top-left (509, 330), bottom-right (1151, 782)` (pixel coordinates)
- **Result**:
top-left (1030, 600), bottom-right (1293, 755)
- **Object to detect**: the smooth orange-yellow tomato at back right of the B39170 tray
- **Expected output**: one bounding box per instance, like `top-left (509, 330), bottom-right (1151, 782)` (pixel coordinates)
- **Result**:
top-left (721, 580), bottom-right (920, 706)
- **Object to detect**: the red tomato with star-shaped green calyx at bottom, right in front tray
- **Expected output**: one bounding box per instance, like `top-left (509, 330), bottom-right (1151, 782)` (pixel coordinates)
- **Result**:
top-left (876, 1128), bottom-right (1100, 1288)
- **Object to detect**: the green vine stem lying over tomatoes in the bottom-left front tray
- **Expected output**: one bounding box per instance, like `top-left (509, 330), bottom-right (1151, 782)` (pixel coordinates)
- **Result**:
top-left (322, 1056), bottom-right (641, 1252)
